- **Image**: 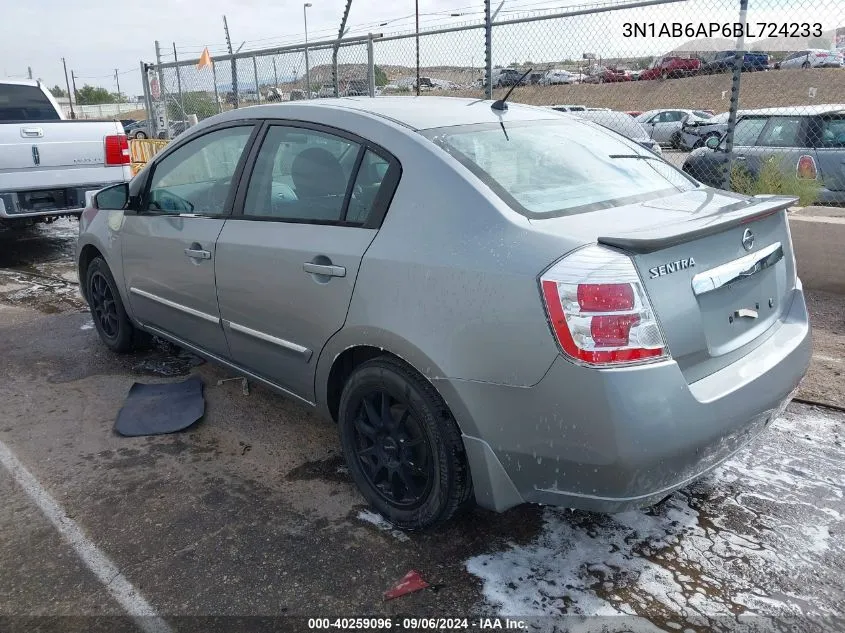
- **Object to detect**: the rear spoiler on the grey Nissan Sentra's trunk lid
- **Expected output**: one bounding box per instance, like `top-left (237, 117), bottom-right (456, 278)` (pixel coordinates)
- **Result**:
top-left (598, 195), bottom-right (798, 253)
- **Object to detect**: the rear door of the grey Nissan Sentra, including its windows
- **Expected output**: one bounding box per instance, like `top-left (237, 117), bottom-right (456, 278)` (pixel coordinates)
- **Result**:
top-left (216, 122), bottom-right (400, 401)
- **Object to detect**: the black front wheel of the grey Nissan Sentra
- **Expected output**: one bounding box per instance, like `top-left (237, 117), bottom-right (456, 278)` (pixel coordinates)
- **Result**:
top-left (85, 257), bottom-right (149, 354)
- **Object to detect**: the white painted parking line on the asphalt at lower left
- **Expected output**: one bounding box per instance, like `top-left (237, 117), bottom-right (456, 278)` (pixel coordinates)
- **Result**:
top-left (0, 441), bottom-right (173, 633)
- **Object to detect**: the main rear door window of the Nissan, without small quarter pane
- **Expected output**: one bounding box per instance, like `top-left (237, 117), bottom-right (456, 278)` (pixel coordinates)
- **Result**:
top-left (244, 125), bottom-right (361, 222)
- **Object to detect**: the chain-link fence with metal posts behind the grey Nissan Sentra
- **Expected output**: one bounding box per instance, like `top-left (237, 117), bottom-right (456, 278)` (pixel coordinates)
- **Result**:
top-left (142, 0), bottom-right (845, 204)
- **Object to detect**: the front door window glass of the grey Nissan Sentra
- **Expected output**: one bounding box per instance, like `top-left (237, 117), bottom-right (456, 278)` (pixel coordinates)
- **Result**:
top-left (145, 125), bottom-right (253, 215)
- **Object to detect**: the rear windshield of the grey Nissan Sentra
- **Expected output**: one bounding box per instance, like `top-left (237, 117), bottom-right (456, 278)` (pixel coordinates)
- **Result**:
top-left (425, 118), bottom-right (698, 218)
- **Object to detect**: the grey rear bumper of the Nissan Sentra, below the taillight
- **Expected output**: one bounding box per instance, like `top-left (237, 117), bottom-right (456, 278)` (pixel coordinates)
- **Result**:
top-left (436, 287), bottom-right (811, 512)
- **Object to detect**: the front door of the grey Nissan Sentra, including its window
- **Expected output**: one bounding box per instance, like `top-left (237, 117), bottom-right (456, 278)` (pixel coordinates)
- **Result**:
top-left (121, 124), bottom-right (255, 357)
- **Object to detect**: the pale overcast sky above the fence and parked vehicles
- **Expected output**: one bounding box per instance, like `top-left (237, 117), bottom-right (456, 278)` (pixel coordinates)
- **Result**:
top-left (0, 0), bottom-right (841, 95)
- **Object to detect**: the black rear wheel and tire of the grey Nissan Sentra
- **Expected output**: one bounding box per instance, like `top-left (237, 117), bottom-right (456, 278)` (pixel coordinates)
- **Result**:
top-left (338, 356), bottom-right (472, 530)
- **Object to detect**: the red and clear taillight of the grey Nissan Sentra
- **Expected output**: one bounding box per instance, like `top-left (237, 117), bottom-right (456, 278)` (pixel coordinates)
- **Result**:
top-left (540, 245), bottom-right (668, 365)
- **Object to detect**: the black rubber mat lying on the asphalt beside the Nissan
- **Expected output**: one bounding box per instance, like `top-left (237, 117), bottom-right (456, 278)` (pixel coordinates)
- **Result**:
top-left (114, 376), bottom-right (205, 437)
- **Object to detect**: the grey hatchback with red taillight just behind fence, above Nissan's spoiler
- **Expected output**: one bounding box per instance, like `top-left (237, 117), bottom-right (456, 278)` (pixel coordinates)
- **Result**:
top-left (683, 105), bottom-right (845, 205)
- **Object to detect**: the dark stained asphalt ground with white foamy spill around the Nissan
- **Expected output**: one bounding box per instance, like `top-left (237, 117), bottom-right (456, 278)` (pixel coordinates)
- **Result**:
top-left (0, 221), bottom-right (845, 631)
